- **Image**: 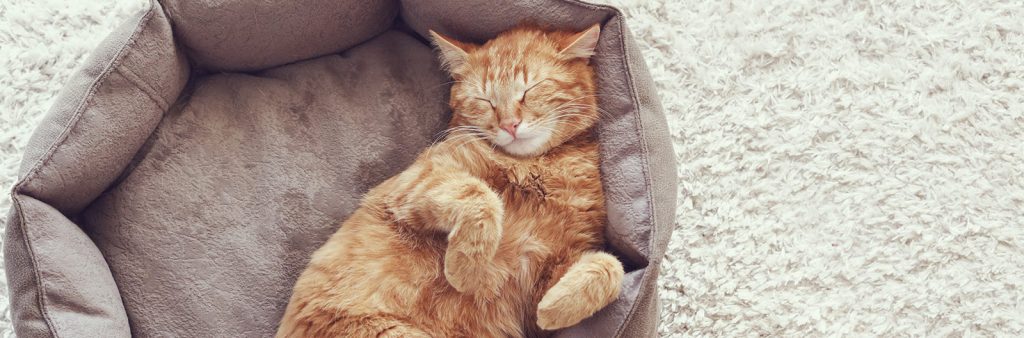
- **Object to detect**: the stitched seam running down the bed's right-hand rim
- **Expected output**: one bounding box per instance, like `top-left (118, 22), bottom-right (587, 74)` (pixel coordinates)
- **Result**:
top-left (565, 0), bottom-right (662, 337)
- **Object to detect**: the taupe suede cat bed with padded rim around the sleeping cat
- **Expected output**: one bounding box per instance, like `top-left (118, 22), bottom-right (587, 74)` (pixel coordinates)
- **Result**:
top-left (4, 0), bottom-right (676, 337)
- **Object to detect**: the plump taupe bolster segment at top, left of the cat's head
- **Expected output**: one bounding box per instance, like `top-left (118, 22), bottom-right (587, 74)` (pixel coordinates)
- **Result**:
top-left (163, 0), bottom-right (398, 71)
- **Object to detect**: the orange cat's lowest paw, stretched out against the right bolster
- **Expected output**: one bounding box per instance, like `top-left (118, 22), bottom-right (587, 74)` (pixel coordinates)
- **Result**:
top-left (537, 251), bottom-right (625, 330)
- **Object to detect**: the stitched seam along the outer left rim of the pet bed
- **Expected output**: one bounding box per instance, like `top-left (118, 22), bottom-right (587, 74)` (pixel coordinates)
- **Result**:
top-left (11, 5), bottom-right (154, 337)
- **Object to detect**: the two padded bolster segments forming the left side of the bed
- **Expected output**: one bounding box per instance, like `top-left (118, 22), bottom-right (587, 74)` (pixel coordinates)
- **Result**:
top-left (4, 3), bottom-right (188, 337)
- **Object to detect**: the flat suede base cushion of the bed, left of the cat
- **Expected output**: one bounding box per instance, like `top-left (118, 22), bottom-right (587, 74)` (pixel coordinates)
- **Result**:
top-left (82, 31), bottom-right (446, 337)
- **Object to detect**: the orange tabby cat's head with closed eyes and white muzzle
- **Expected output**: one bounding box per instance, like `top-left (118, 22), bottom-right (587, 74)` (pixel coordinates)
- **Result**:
top-left (430, 25), bottom-right (601, 157)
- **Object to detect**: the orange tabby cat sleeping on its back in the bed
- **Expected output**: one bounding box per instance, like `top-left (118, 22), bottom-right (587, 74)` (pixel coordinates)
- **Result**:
top-left (278, 25), bottom-right (623, 337)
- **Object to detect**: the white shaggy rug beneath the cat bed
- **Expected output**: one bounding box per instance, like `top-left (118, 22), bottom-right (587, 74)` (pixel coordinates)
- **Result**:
top-left (0, 0), bottom-right (1024, 337)
